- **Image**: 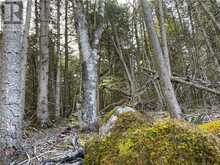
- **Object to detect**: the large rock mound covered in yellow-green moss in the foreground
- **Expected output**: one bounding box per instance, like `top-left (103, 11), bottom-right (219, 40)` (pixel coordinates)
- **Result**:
top-left (85, 112), bottom-right (220, 165)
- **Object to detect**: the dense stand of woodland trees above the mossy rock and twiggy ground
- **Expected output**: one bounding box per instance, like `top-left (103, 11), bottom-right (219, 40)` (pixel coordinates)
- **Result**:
top-left (0, 0), bottom-right (220, 164)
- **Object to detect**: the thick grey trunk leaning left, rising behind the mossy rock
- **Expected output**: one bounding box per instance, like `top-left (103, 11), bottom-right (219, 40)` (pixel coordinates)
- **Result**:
top-left (140, 0), bottom-right (182, 119)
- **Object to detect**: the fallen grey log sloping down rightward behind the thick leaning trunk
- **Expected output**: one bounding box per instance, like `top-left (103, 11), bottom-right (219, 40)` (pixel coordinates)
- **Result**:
top-left (142, 67), bottom-right (220, 96)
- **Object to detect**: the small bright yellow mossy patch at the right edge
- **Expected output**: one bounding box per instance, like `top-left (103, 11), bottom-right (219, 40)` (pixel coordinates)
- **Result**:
top-left (199, 119), bottom-right (220, 136)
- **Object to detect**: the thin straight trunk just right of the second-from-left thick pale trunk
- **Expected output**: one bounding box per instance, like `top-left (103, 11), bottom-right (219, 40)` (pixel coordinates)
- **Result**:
top-left (55, 1), bottom-right (61, 119)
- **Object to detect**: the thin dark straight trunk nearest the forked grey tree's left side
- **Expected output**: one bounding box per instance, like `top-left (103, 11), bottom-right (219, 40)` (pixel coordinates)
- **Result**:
top-left (63, 0), bottom-right (69, 116)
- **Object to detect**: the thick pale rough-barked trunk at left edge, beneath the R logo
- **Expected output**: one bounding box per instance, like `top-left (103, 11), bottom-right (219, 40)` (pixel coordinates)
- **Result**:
top-left (0, 0), bottom-right (24, 164)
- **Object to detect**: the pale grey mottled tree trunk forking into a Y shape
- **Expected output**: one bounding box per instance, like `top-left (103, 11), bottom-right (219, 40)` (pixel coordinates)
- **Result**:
top-left (74, 0), bottom-right (105, 130)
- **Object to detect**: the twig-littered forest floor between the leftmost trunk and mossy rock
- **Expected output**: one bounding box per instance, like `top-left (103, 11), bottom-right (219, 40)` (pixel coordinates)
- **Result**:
top-left (16, 117), bottom-right (93, 165)
